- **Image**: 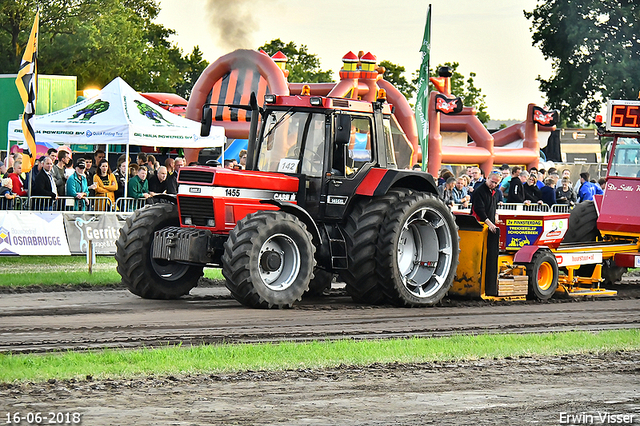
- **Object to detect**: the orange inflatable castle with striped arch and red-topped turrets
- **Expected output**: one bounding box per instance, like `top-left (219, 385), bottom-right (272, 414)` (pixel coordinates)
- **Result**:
top-left (185, 50), bottom-right (557, 175)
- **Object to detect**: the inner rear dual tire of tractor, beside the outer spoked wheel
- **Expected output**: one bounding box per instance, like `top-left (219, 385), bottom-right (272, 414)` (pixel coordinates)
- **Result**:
top-left (340, 190), bottom-right (406, 305)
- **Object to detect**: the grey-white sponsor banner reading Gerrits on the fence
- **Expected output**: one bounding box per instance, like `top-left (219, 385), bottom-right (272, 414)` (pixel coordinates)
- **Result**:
top-left (64, 213), bottom-right (125, 254)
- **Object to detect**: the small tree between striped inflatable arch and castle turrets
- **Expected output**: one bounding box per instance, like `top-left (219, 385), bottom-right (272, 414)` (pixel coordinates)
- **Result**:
top-left (258, 38), bottom-right (332, 83)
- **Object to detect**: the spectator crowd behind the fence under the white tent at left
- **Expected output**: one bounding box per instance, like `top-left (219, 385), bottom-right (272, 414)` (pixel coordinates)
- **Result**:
top-left (0, 148), bottom-right (185, 211)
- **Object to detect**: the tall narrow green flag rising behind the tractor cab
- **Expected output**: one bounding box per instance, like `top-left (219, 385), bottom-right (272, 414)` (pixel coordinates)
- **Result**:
top-left (416, 5), bottom-right (431, 171)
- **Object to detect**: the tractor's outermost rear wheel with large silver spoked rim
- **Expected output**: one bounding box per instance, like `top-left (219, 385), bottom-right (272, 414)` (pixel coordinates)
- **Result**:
top-left (376, 192), bottom-right (459, 307)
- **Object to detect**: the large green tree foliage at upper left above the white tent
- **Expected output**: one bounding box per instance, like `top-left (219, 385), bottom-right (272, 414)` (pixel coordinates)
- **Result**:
top-left (0, 0), bottom-right (208, 96)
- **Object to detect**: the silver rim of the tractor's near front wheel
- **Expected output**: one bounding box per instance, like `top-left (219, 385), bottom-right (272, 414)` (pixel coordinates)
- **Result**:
top-left (258, 234), bottom-right (301, 291)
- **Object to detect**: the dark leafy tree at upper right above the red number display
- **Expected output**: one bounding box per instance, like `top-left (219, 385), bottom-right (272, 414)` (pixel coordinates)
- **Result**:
top-left (524, 0), bottom-right (640, 123)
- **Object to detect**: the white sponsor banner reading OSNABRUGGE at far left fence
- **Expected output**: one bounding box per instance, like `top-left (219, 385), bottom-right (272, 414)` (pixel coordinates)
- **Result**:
top-left (0, 211), bottom-right (70, 256)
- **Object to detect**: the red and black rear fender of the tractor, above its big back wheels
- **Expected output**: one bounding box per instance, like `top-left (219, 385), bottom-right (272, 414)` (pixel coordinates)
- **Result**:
top-left (356, 167), bottom-right (438, 197)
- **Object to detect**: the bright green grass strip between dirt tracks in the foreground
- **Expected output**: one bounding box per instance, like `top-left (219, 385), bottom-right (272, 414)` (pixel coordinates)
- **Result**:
top-left (0, 330), bottom-right (640, 382)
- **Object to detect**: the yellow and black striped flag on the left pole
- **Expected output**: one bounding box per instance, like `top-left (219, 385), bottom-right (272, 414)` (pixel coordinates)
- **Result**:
top-left (16, 11), bottom-right (40, 173)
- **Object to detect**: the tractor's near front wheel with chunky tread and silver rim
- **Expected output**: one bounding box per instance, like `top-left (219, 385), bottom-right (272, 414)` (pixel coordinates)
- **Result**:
top-left (222, 211), bottom-right (316, 308)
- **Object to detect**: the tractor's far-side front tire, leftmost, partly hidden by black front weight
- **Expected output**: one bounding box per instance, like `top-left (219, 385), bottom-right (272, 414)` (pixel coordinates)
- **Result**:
top-left (116, 203), bottom-right (203, 299)
